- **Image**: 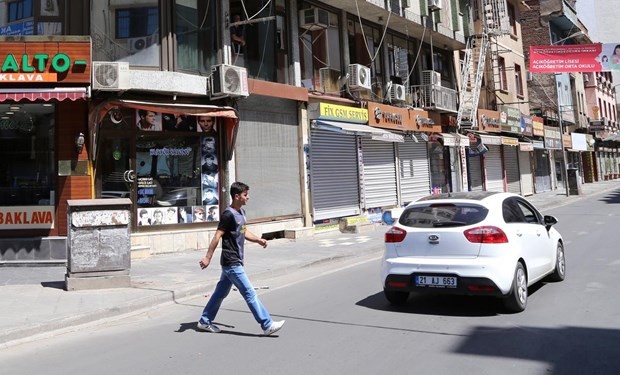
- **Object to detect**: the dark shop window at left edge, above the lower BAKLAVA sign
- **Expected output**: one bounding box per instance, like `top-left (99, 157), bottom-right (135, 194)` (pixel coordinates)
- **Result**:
top-left (0, 103), bottom-right (57, 206)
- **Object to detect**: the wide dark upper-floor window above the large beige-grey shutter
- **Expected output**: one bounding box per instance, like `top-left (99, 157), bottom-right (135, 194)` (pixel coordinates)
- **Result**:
top-left (229, 0), bottom-right (290, 83)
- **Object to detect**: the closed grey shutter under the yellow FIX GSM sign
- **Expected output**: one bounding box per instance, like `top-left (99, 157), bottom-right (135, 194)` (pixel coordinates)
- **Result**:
top-left (312, 129), bottom-right (360, 221)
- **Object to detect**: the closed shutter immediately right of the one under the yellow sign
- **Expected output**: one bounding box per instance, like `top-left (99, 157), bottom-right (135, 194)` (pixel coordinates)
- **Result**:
top-left (362, 138), bottom-right (398, 209)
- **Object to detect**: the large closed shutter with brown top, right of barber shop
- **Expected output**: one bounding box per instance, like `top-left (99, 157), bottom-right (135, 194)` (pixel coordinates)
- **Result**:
top-left (235, 95), bottom-right (302, 219)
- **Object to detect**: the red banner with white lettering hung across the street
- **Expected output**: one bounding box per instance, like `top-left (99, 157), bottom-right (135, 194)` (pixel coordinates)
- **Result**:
top-left (530, 43), bottom-right (604, 73)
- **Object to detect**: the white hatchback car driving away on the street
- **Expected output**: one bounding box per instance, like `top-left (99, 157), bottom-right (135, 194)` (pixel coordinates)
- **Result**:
top-left (381, 192), bottom-right (566, 312)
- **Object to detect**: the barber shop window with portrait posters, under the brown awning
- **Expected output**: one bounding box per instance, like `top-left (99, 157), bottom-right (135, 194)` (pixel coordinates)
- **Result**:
top-left (96, 108), bottom-right (220, 226)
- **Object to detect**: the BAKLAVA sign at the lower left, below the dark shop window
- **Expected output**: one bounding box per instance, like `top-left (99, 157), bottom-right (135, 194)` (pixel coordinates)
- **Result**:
top-left (0, 206), bottom-right (54, 230)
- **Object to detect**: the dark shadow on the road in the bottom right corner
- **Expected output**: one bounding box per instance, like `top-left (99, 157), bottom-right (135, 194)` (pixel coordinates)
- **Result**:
top-left (454, 327), bottom-right (620, 375)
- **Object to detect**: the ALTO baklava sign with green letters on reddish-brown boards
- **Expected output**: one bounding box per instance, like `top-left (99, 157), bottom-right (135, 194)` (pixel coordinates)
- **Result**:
top-left (0, 36), bottom-right (90, 84)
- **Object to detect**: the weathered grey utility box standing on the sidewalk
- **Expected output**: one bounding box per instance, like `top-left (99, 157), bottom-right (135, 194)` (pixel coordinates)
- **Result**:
top-left (65, 198), bottom-right (131, 290)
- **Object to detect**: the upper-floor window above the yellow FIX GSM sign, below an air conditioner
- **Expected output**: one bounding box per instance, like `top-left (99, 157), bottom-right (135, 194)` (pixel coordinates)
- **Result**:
top-left (299, 6), bottom-right (343, 92)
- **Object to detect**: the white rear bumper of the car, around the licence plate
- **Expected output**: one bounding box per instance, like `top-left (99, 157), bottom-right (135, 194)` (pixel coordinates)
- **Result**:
top-left (381, 257), bottom-right (517, 296)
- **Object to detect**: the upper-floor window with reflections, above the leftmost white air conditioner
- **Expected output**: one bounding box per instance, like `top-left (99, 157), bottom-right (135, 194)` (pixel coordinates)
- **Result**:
top-left (91, 0), bottom-right (161, 66)
